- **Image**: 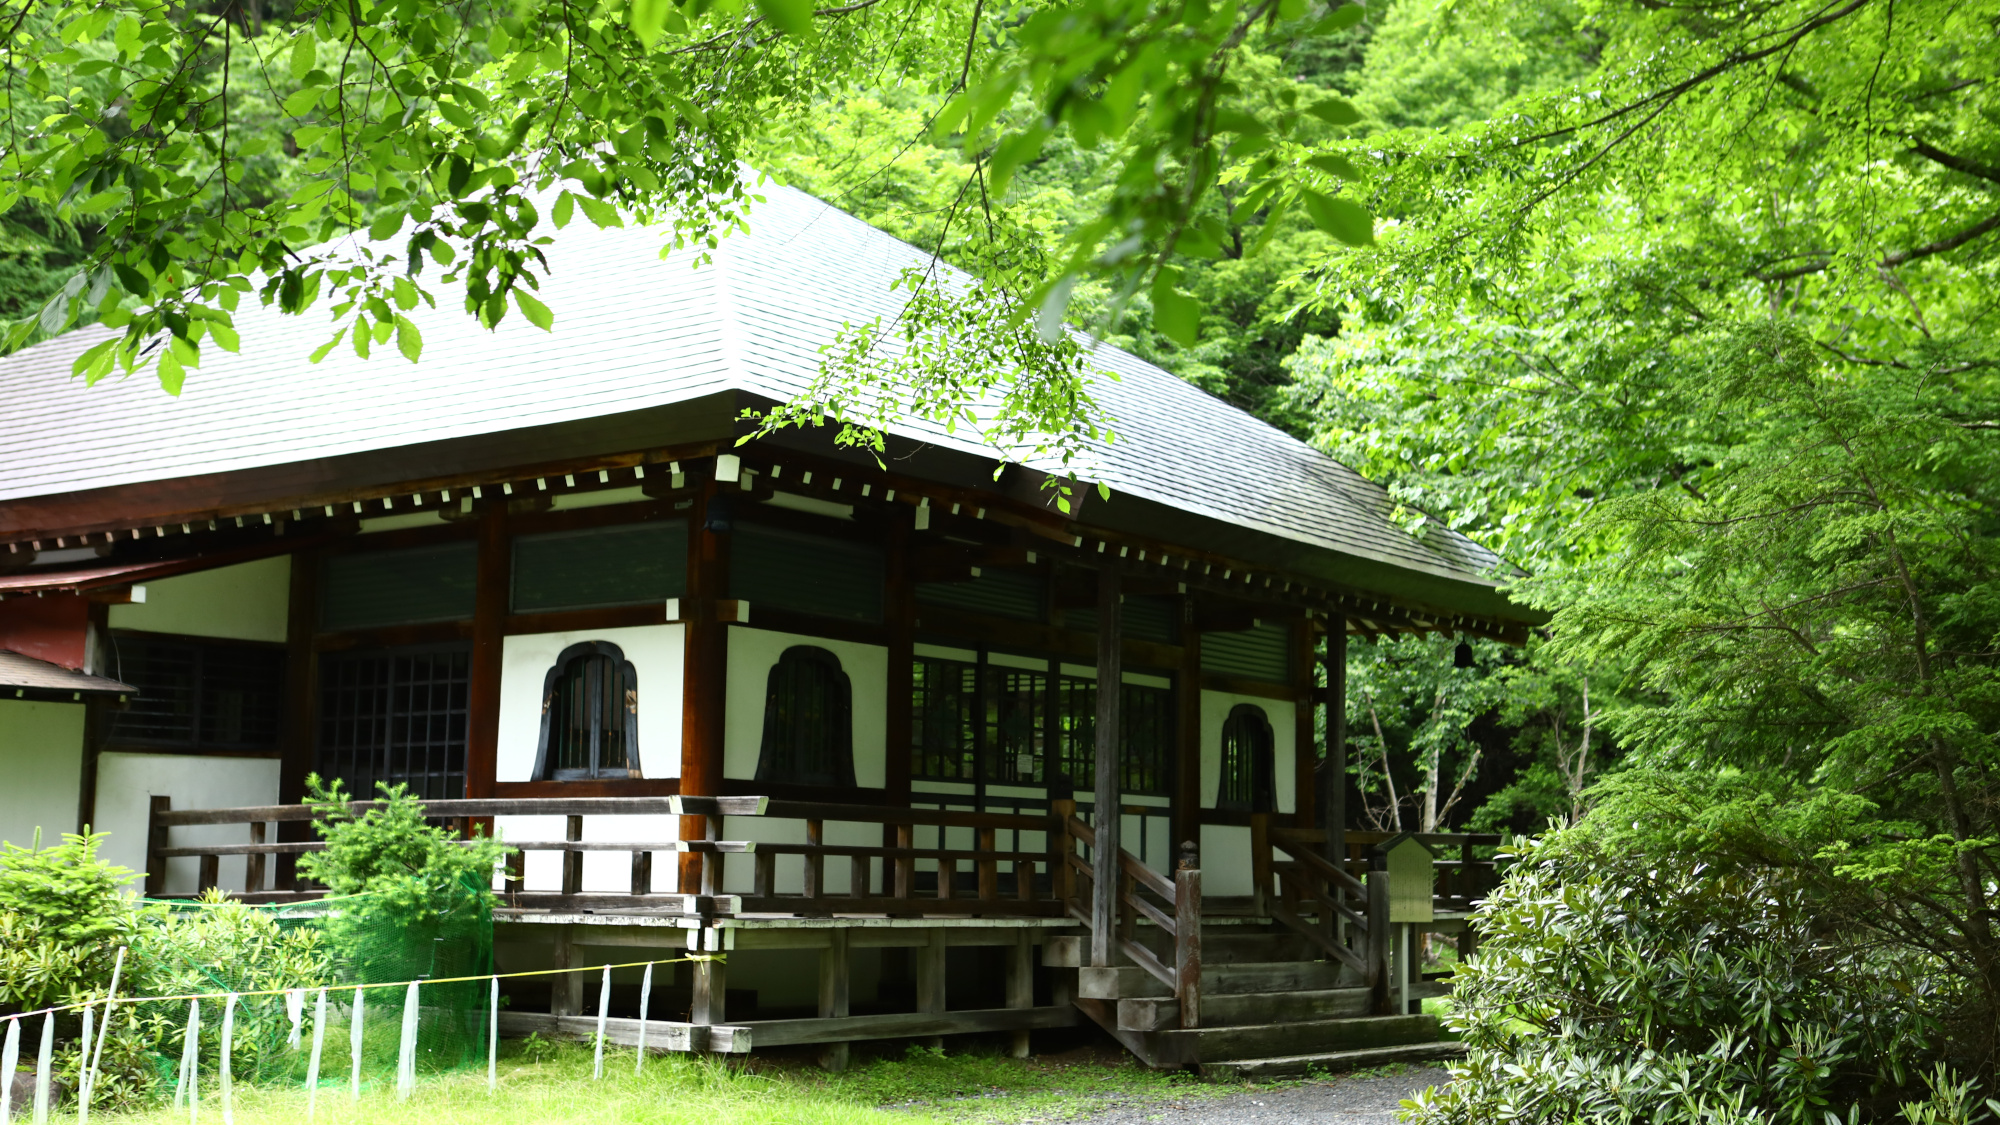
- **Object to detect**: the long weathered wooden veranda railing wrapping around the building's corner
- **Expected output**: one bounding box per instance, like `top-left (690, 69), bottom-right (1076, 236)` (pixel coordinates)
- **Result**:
top-left (146, 797), bottom-right (1064, 917)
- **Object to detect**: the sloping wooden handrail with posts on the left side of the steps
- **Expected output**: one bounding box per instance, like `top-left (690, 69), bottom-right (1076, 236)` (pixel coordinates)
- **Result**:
top-left (1052, 801), bottom-right (1202, 1027)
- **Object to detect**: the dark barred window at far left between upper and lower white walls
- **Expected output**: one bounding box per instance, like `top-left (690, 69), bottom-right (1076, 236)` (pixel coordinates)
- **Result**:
top-left (110, 631), bottom-right (284, 751)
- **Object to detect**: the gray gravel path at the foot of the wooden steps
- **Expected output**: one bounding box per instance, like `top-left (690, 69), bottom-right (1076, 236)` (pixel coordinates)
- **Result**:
top-left (1078, 1067), bottom-right (1448, 1125)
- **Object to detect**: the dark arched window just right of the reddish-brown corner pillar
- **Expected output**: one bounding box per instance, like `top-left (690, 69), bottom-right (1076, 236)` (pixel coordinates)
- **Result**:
top-left (756, 645), bottom-right (854, 787)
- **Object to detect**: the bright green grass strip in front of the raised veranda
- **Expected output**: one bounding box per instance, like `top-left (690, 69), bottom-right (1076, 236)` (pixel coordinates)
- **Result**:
top-left (94, 1043), bottom-right (1232, 1125)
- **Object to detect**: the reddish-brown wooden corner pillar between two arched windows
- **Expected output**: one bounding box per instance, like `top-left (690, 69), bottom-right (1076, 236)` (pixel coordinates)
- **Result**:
top-left (676, 478), bottom-right (730, 892)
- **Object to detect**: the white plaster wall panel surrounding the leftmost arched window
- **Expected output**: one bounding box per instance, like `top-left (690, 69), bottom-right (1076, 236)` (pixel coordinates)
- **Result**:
top-left (494, 625), bottom-right (688, 780)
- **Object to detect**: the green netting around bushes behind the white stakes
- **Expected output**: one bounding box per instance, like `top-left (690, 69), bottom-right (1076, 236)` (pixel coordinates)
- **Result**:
top-left (136, 895), bottom-right (492, 1091)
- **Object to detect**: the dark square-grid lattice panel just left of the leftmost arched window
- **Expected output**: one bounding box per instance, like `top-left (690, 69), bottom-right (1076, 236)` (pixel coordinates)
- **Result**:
top-left (316, 645), bottom-right (472, 799)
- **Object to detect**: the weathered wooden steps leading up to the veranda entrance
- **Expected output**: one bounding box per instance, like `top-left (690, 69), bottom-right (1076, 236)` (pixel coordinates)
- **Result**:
top-left (1042, 923), bottom-right (1460, 1077)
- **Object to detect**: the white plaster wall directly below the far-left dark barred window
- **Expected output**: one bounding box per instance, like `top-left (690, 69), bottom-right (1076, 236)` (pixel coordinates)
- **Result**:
top-left (96, 753), bottom-right (278, 895)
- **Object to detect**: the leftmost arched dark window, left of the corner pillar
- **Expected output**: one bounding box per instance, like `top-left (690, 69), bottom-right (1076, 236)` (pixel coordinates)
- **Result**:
top-left (534, 641), bottom-right (638, 781)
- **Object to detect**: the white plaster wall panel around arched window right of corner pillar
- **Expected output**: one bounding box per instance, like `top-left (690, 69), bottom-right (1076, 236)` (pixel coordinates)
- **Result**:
top-left (722, 627), bottom-right (888, 784)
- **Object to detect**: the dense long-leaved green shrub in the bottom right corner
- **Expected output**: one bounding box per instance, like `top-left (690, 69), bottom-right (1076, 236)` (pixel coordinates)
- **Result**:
top-left (1408, 829), bottom-right (2000, 1125)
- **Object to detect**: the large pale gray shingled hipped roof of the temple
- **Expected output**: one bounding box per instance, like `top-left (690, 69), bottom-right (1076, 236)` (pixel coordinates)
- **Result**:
top-left (0, 184), bottom-right (1498, 585)
